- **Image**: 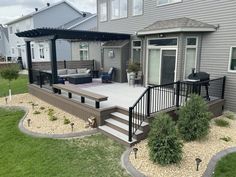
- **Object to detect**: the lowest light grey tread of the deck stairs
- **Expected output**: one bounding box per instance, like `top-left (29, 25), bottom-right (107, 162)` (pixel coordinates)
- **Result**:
top-left (99, 125), bottom-right (137, 144)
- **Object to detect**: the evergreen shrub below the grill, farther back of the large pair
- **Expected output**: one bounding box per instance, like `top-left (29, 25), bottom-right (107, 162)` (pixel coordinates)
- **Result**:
top-left (178, 95), bottom-right (211, 141)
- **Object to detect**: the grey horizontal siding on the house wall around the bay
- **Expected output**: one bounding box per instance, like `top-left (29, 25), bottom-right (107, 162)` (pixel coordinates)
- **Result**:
top-left (98, 0), bottom-right (236, 111)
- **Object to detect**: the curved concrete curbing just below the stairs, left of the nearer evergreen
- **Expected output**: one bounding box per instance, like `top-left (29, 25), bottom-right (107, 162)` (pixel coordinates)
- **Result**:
top-left (121, 148), bottom-right (146, 177)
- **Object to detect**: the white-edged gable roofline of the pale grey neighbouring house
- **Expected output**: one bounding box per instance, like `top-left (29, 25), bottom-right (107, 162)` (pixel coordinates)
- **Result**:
top-left (6, 0), bottom-right (83, 25)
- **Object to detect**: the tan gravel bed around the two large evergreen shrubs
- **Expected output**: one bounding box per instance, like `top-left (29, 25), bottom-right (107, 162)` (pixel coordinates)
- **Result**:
top-left (129, 116), bottom-right (236, 177)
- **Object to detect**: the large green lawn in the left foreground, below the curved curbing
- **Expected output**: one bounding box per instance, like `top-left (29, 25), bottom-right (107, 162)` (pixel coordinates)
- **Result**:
top-left (0, 108), bottom-right (128, 177)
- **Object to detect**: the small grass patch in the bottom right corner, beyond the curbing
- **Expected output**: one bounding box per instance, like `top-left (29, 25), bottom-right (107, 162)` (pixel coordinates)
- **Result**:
top-left (214, 153), bottom-right (236, 177)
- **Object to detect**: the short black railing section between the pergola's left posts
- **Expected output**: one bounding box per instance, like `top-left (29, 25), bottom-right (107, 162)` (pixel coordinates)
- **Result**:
top-left (32, 70), bottom-right (52, 88)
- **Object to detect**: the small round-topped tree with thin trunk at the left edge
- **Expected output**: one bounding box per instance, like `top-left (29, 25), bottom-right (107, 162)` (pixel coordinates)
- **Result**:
top-left (0, 65), bottom-right (19, 100)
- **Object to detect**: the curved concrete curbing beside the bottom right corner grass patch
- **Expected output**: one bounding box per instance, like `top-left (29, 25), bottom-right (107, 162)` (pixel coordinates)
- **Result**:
top-left (202, 147), bottom-right (236, 177)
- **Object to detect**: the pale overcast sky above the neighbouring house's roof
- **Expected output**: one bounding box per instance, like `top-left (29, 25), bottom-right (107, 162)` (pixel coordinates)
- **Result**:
top-left (0, 0), bottom-right (96, 24)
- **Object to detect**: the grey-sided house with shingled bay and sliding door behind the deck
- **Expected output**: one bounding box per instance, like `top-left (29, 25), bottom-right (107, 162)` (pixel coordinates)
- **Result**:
top-left (97, 0), bottom-right (236, 111)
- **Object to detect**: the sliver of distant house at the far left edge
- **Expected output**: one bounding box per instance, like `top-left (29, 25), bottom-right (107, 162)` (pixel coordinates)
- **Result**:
top-left (0, 24), bottom-right (10, 59)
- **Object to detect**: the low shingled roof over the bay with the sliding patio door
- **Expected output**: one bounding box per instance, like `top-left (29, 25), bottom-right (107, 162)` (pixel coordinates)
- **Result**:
top-left (137, 17), bottom-right (216, 35)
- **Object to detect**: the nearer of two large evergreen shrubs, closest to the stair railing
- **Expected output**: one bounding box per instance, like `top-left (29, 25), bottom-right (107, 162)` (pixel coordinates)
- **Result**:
top-left (148, 114), bottom-right (183, 165)
